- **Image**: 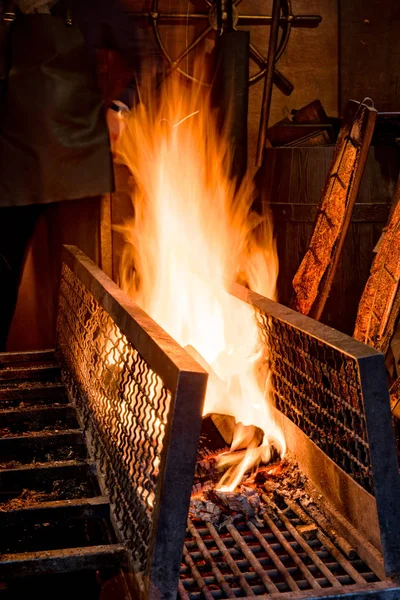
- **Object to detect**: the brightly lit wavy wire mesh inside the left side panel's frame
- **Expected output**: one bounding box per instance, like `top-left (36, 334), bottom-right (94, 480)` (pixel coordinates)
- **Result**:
top-left (57, 264), bottom-right (171, 571)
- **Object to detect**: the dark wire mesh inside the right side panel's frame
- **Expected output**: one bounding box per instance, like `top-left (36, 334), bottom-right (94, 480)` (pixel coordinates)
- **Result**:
top-left (258, 311), bottom-right (373, 494)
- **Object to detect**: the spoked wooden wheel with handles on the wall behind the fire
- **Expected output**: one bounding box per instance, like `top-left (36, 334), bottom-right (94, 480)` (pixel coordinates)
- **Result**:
top-left (146, 0), bottom-right (321, 89)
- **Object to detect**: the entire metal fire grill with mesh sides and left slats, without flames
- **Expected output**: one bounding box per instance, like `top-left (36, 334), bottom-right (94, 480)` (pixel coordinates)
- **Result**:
top-left (0, 247), bottom-right (400, 600)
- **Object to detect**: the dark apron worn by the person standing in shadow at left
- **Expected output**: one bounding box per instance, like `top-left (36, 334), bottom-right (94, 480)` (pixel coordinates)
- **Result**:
top-left (0, 14), bottom-right (113, 206)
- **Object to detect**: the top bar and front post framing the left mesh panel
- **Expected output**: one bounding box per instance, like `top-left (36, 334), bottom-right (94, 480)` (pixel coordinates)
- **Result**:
top-left (56, 246), bottom-right (208, 600)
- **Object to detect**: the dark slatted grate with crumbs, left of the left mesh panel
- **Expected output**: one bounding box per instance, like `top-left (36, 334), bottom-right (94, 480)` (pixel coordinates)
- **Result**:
top-left (0, 352), bottom-right (125, 600)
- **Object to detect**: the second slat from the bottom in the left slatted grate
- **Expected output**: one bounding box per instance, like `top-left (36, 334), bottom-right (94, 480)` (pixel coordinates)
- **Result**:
top-left (0, 496), bottom-right (110, 527)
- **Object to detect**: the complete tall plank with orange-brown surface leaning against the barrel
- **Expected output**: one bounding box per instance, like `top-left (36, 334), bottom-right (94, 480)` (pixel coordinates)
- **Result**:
top-left (291, 100), bottom-right (376, 320)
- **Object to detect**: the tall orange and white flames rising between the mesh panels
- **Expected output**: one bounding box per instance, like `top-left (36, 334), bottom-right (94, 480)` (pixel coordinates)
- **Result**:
top-left (114, 69), bottom-right (285, 490)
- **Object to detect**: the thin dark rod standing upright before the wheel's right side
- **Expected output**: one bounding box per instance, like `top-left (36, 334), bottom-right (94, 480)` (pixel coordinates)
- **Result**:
top-left (256, 0), bottom-right (281, 167)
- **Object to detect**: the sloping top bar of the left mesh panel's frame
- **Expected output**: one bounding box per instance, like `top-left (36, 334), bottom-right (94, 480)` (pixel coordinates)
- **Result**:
top-left (63, 246), bottom-right (206, 394)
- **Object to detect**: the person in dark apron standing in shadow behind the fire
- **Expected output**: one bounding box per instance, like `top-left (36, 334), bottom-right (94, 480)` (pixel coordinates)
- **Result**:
top-left (0, 0), bottom-right (163, 351)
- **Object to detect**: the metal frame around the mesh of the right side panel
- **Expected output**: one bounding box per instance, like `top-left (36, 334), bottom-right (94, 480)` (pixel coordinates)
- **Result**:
top-left (231, 284), bottom-right (400, 577)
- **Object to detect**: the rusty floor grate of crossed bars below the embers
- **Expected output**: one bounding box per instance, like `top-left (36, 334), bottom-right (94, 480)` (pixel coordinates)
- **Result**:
top-left (178, 505), bottom-right (380, 600)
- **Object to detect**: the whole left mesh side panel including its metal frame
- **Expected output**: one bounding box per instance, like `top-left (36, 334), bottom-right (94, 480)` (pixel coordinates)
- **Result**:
top-left (57, 248), bottom-right (207, 599)
